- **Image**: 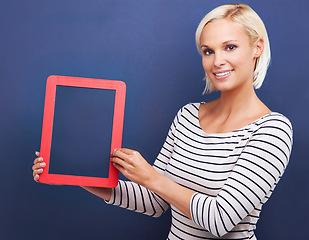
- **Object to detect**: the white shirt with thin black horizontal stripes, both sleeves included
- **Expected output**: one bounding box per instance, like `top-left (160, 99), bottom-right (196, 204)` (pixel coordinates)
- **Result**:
top-left (109, 103), bottom-right (292, 240)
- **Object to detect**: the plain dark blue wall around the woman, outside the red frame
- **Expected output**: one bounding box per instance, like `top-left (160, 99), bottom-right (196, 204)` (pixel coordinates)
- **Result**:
top-left (0, 0), bottom-right (309, 240)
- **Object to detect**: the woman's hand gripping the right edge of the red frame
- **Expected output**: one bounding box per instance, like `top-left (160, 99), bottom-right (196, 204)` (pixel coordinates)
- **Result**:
top-left (111, 148), bottom-right (159, 189)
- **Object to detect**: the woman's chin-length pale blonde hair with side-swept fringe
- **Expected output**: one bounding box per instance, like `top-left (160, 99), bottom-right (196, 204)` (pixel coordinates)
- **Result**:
top-left (195, 4), bottom-right (271, 93)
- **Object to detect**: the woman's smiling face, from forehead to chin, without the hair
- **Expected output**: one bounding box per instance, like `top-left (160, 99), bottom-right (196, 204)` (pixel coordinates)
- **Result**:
top-left (200, 19), bottom-right (263, 92)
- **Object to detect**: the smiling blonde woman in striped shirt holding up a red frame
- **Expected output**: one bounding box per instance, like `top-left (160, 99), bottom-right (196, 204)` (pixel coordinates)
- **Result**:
top-left (33, 4), bottom-right (292, 239)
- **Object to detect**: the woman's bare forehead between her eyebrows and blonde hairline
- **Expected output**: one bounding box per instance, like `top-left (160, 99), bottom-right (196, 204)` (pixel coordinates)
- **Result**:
top-left (200, 19), bottom-right (249, 46)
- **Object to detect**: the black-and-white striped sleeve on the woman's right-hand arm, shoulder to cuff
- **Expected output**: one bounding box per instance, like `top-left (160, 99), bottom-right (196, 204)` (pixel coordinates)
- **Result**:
top-left (191, 115), bottom-right (292, 237)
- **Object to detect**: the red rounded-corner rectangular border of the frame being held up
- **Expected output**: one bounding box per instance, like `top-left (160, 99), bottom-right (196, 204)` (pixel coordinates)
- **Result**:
top-left (40, 75), bottom-right (126, 188)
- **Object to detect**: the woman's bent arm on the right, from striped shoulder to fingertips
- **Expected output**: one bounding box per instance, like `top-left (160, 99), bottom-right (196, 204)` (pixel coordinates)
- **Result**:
top-left (112, 114), bottom-right (292, 236)
